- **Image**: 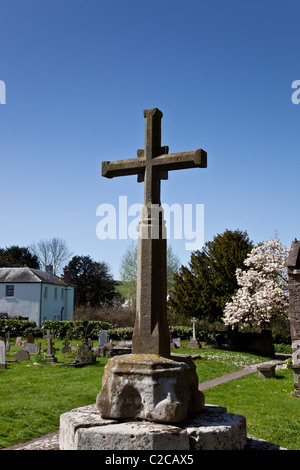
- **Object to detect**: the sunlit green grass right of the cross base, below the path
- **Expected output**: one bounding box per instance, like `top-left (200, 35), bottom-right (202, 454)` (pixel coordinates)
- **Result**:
top-left (205, 369), bottom-right (300, 450)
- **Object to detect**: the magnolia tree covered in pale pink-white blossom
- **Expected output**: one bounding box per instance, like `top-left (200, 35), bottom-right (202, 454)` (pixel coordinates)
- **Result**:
top-left (223, 238), bottom-right (288, 327)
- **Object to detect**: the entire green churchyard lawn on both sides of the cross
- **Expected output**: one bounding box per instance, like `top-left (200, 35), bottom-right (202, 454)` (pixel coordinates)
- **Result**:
top-left (0, 340), bottom-right (300, 450)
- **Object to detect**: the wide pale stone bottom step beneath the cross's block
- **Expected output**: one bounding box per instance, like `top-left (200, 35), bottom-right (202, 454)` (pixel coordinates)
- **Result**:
top-left (59, 405), bottom-right (247, 451)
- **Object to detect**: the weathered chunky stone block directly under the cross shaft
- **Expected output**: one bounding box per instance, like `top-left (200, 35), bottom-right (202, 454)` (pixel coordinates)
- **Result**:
top-left (97, 354), bottom-right (204, 423)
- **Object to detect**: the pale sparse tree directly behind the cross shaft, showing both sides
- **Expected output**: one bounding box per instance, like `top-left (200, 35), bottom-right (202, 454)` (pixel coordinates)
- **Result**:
top-left (120, 242), bottom-right (180, 306)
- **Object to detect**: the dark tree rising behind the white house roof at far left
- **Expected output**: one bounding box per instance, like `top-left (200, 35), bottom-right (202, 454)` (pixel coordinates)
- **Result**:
top-left (0, 245), bottom-right (40, 269)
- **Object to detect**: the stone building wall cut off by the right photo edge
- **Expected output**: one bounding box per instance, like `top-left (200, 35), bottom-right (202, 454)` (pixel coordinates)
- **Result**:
top-left (286, 239), bottom-right (300, 397)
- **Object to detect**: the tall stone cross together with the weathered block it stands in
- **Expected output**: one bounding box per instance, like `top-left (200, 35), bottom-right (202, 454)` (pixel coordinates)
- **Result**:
top-left (97, 108), bottom-right (207, 422)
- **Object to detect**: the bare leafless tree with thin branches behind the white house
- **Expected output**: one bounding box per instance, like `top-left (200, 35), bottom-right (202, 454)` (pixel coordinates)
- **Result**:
top-left (30, 237), bottom-right (72, 274)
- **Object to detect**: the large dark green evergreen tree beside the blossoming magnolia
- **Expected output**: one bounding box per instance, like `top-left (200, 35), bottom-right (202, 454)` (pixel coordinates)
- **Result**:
top-left (169, 230), bottom-right (253, 320)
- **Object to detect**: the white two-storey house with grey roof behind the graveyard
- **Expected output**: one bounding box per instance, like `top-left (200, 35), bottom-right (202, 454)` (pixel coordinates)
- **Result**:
top-left (0, 266), bottom-right (74, 326)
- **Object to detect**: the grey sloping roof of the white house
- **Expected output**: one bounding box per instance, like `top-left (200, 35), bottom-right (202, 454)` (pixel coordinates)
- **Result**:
top-left (0, 266), bottom-right (68, 286)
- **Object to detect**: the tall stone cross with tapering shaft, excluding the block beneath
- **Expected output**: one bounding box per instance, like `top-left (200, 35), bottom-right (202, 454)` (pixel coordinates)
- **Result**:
top-left (102, 108), bottom-right (207, 355)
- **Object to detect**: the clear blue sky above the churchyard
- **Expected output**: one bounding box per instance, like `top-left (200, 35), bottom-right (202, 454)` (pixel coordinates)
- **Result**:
top-left (0, 0), bottom-right (300, 278)
